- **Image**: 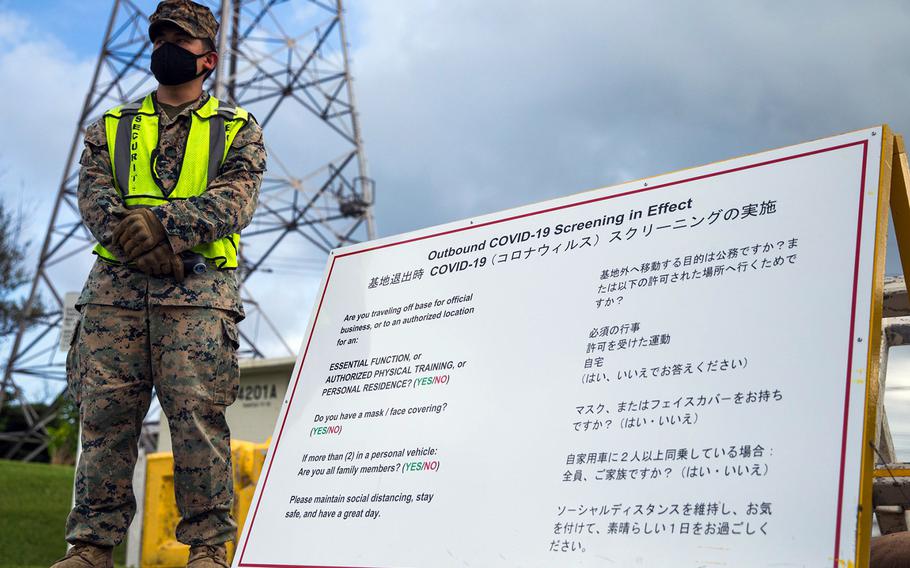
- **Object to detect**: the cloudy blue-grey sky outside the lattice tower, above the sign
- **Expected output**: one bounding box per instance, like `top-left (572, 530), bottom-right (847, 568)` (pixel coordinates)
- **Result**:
top-left (0, 0), bottom-right (910, 457)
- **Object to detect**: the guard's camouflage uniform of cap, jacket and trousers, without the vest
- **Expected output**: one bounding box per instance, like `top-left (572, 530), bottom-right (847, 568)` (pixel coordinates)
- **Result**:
top-left (55, 0), bottom-right (266, 565)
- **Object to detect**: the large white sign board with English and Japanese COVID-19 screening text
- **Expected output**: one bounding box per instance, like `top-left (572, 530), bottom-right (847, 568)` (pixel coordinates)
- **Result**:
top-left (234, 128), bottom-right (883, 568)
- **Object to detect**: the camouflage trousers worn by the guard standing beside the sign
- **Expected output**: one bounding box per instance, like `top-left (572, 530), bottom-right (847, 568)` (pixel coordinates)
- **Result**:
top-left (66, 304), bottom-right (239, 546)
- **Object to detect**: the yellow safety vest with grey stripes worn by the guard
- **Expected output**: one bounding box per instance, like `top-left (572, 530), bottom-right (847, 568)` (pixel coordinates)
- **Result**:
top-left (92, 94), bottom-right (249, 269)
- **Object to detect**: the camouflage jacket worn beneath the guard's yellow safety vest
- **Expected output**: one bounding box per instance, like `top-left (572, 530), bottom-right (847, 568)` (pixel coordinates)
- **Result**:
top-left (77, 93), bottom-right (266, 321)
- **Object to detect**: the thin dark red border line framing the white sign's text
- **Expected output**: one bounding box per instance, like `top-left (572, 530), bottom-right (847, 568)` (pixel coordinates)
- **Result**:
top-left (238, 140), bottom-right (869, 568)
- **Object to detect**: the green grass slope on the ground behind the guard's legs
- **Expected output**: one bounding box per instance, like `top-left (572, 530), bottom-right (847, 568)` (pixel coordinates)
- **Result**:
top-left (0, 460), bottom-right (126, 567)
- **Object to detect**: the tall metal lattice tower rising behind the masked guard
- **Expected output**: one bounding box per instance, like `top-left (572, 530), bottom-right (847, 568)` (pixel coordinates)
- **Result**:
top-left (0, 0), bottom-right (374, 460)
